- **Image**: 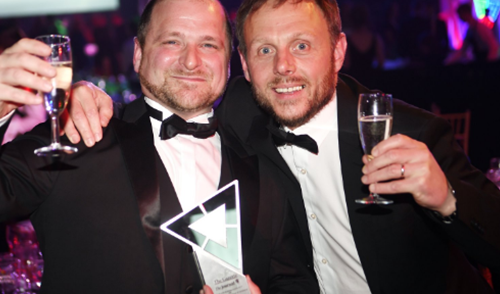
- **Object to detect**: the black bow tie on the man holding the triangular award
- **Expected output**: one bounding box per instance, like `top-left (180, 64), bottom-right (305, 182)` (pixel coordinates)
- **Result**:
top-left (146, 103), bottom-right (218, 140)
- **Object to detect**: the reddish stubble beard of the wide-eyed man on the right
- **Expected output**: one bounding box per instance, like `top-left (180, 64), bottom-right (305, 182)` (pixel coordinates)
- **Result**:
top-left (252, 59), bottom-right (337, 129)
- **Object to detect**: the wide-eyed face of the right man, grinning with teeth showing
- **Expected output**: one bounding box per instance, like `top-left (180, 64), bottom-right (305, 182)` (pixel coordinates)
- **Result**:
top-left (240, 1), bottom-right (347, 129)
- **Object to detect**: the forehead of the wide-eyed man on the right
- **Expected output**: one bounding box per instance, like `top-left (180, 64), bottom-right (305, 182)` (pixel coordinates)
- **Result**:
top-left (244, 1), bottom-right (329, 44)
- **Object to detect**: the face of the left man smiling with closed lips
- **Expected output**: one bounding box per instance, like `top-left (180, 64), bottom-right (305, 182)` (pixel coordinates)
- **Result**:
top-left (134, 0), bottom-right (230, 119)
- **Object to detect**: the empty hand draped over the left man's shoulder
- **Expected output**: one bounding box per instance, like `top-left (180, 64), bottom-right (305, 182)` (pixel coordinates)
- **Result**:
top-left (64, 81), bottom-right (113, 147)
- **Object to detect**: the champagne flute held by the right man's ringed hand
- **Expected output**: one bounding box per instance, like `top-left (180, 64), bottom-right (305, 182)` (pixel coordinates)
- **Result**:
top-left (356, 93), bottom-right (393, 204)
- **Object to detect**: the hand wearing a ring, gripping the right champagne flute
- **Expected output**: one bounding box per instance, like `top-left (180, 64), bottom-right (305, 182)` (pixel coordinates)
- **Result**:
top-left (361, 134), bottom-right (456, 216)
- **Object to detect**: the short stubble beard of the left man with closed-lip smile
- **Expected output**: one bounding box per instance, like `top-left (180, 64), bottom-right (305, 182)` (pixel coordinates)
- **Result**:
top-left (139, 68), bottom-right (223, 113)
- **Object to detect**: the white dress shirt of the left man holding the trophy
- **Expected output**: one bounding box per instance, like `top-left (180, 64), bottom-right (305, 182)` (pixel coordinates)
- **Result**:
top-left (145, 97), bottom-right (222, 211)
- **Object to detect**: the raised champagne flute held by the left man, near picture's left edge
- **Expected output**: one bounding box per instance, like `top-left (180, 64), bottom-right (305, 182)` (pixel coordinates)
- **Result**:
top-left (35, 35), bottom-right (78, 156)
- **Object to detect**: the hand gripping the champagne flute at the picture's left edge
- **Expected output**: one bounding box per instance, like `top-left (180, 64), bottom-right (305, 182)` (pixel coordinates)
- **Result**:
top-left (0, 39), bottom-right (56, 117)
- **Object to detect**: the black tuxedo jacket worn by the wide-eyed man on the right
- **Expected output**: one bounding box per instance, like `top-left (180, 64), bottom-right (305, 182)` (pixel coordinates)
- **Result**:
top-left (218, 75), bottom-right (500, 294)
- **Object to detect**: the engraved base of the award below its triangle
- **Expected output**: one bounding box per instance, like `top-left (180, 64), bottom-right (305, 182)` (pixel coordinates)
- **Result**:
top-left (193, 250), bottom-right (250, 294)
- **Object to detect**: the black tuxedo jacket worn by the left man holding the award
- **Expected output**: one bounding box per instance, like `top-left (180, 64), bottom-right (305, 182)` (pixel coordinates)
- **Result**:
top-left (0, 99), bottom-right (318, 294)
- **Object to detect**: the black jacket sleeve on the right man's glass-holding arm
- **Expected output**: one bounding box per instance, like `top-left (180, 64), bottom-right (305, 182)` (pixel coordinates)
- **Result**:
top-left (418, 117), bottom-right (500, 269)
